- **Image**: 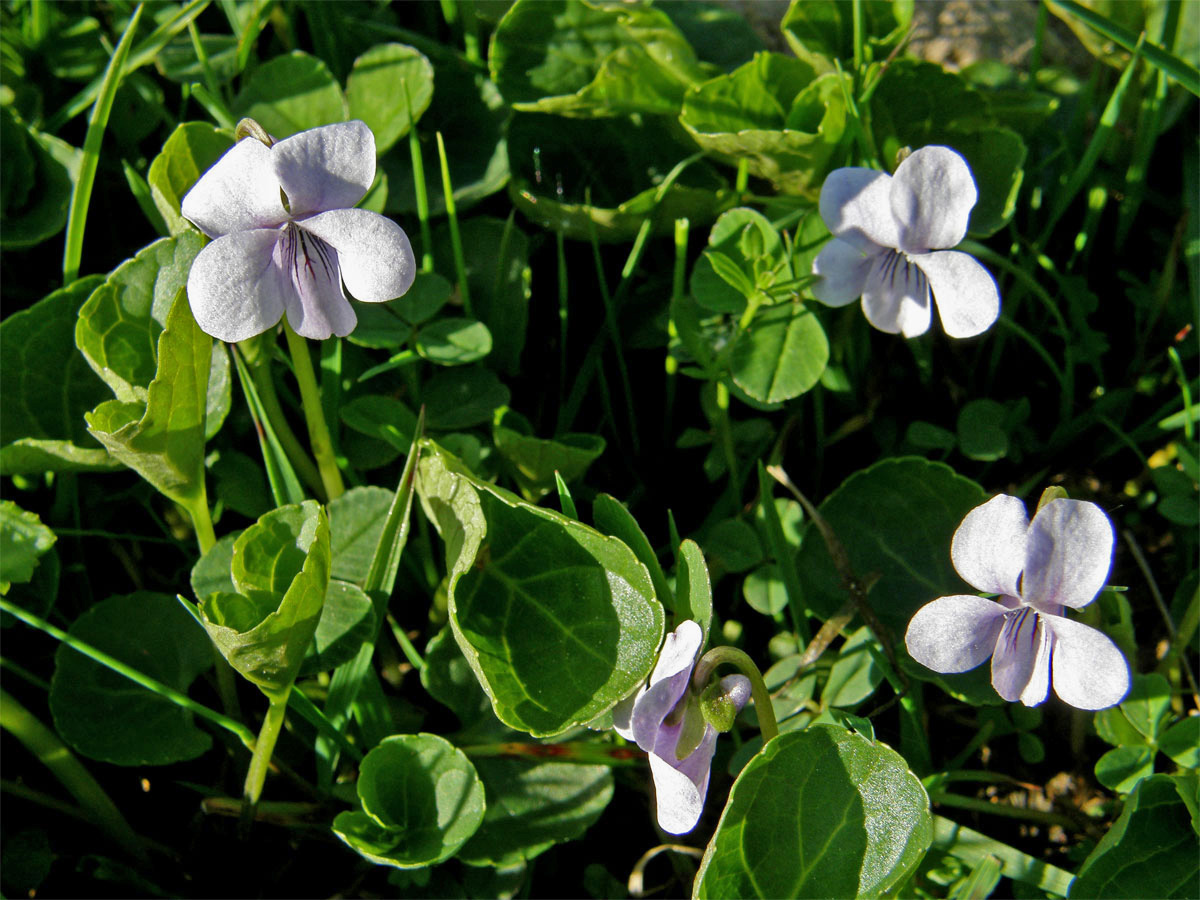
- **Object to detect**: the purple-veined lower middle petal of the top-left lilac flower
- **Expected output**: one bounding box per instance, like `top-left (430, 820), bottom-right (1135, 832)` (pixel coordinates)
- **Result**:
top-left (275, 223), bottom-right (358, 341)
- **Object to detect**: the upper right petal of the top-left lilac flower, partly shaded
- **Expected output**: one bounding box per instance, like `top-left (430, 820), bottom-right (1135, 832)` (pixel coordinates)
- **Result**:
top-left (271, 121), bottom-right (376, 218)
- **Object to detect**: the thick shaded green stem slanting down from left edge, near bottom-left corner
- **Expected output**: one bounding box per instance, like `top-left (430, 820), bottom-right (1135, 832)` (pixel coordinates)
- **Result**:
top-left (0, 690), bottom-right (146, 862)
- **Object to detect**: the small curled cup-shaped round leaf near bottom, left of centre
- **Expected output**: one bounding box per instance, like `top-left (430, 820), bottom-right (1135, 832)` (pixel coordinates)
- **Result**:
top-left (334, 734), bottom-right (485, 869)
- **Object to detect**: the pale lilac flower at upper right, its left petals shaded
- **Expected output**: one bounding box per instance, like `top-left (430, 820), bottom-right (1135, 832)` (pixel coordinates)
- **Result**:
top-left (812, 146), bottom-right (1000, 337)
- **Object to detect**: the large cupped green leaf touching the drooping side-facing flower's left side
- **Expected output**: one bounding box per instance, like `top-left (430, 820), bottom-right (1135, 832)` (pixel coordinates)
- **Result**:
top-left (418, 443), bottom-right (664, 736)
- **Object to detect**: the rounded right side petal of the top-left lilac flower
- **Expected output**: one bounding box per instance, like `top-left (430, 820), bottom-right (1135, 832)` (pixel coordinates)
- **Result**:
top-left (298, 209), bottom-right (416, 302)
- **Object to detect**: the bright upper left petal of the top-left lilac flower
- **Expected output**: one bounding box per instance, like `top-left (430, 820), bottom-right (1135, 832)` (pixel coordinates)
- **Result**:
top-left (181, 138), bottom-right (288, 238)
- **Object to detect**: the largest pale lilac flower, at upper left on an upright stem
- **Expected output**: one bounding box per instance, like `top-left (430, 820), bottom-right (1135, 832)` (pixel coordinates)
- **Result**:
top-left (182, 121), bottom-right (416, 341)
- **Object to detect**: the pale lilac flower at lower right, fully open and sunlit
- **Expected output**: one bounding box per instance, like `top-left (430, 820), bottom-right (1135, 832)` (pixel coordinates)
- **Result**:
top-left (905, 494), bottom-right (1129, 709)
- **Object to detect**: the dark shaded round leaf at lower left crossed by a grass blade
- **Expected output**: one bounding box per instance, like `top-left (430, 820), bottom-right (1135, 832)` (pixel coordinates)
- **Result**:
top-left (50, 592), bottom-right (212, 766)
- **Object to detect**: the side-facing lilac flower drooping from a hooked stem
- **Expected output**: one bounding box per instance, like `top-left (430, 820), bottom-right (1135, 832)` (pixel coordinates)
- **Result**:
top-left (613, 620), bottom-right (750, 834)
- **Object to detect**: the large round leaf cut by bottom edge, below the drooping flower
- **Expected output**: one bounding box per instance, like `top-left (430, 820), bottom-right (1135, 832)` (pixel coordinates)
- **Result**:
top-left (694, 725), bottom-right (934, 898)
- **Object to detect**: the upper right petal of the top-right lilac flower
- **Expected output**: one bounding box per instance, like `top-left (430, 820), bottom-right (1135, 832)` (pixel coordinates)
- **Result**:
top-left (890, 146), bottom-right (979, 253)
